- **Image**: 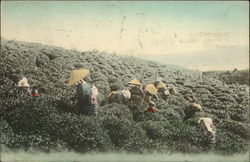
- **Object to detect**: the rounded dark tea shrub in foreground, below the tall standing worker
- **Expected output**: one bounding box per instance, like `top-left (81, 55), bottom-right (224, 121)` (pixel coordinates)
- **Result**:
top-left (54, 113), bottom-right (112, 152)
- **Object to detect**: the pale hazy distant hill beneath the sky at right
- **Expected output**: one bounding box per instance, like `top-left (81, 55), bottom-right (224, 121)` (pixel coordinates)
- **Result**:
top-left (145, 46), bottom-right (249, 71)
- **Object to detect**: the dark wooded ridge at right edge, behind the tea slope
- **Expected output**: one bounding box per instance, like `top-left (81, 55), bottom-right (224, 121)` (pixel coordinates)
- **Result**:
top-left (203, 69), bottom-right (249, 86)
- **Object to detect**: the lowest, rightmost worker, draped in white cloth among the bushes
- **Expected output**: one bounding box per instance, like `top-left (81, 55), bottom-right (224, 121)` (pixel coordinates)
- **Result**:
top-left (198, 117), bottom-right (216, 144)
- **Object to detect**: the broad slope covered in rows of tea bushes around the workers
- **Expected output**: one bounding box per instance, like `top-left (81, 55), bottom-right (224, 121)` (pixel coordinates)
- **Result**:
top-left (0, 39), bottom-right (249, 153)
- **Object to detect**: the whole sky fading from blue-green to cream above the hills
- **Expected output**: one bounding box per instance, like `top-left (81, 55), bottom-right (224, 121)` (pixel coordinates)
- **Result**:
top-left (1, 1), bottom-right (249, 71)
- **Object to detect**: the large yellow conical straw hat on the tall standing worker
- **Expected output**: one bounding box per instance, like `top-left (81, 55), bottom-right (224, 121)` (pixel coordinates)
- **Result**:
top-left (68, 69), bottom-right (89, 86)
